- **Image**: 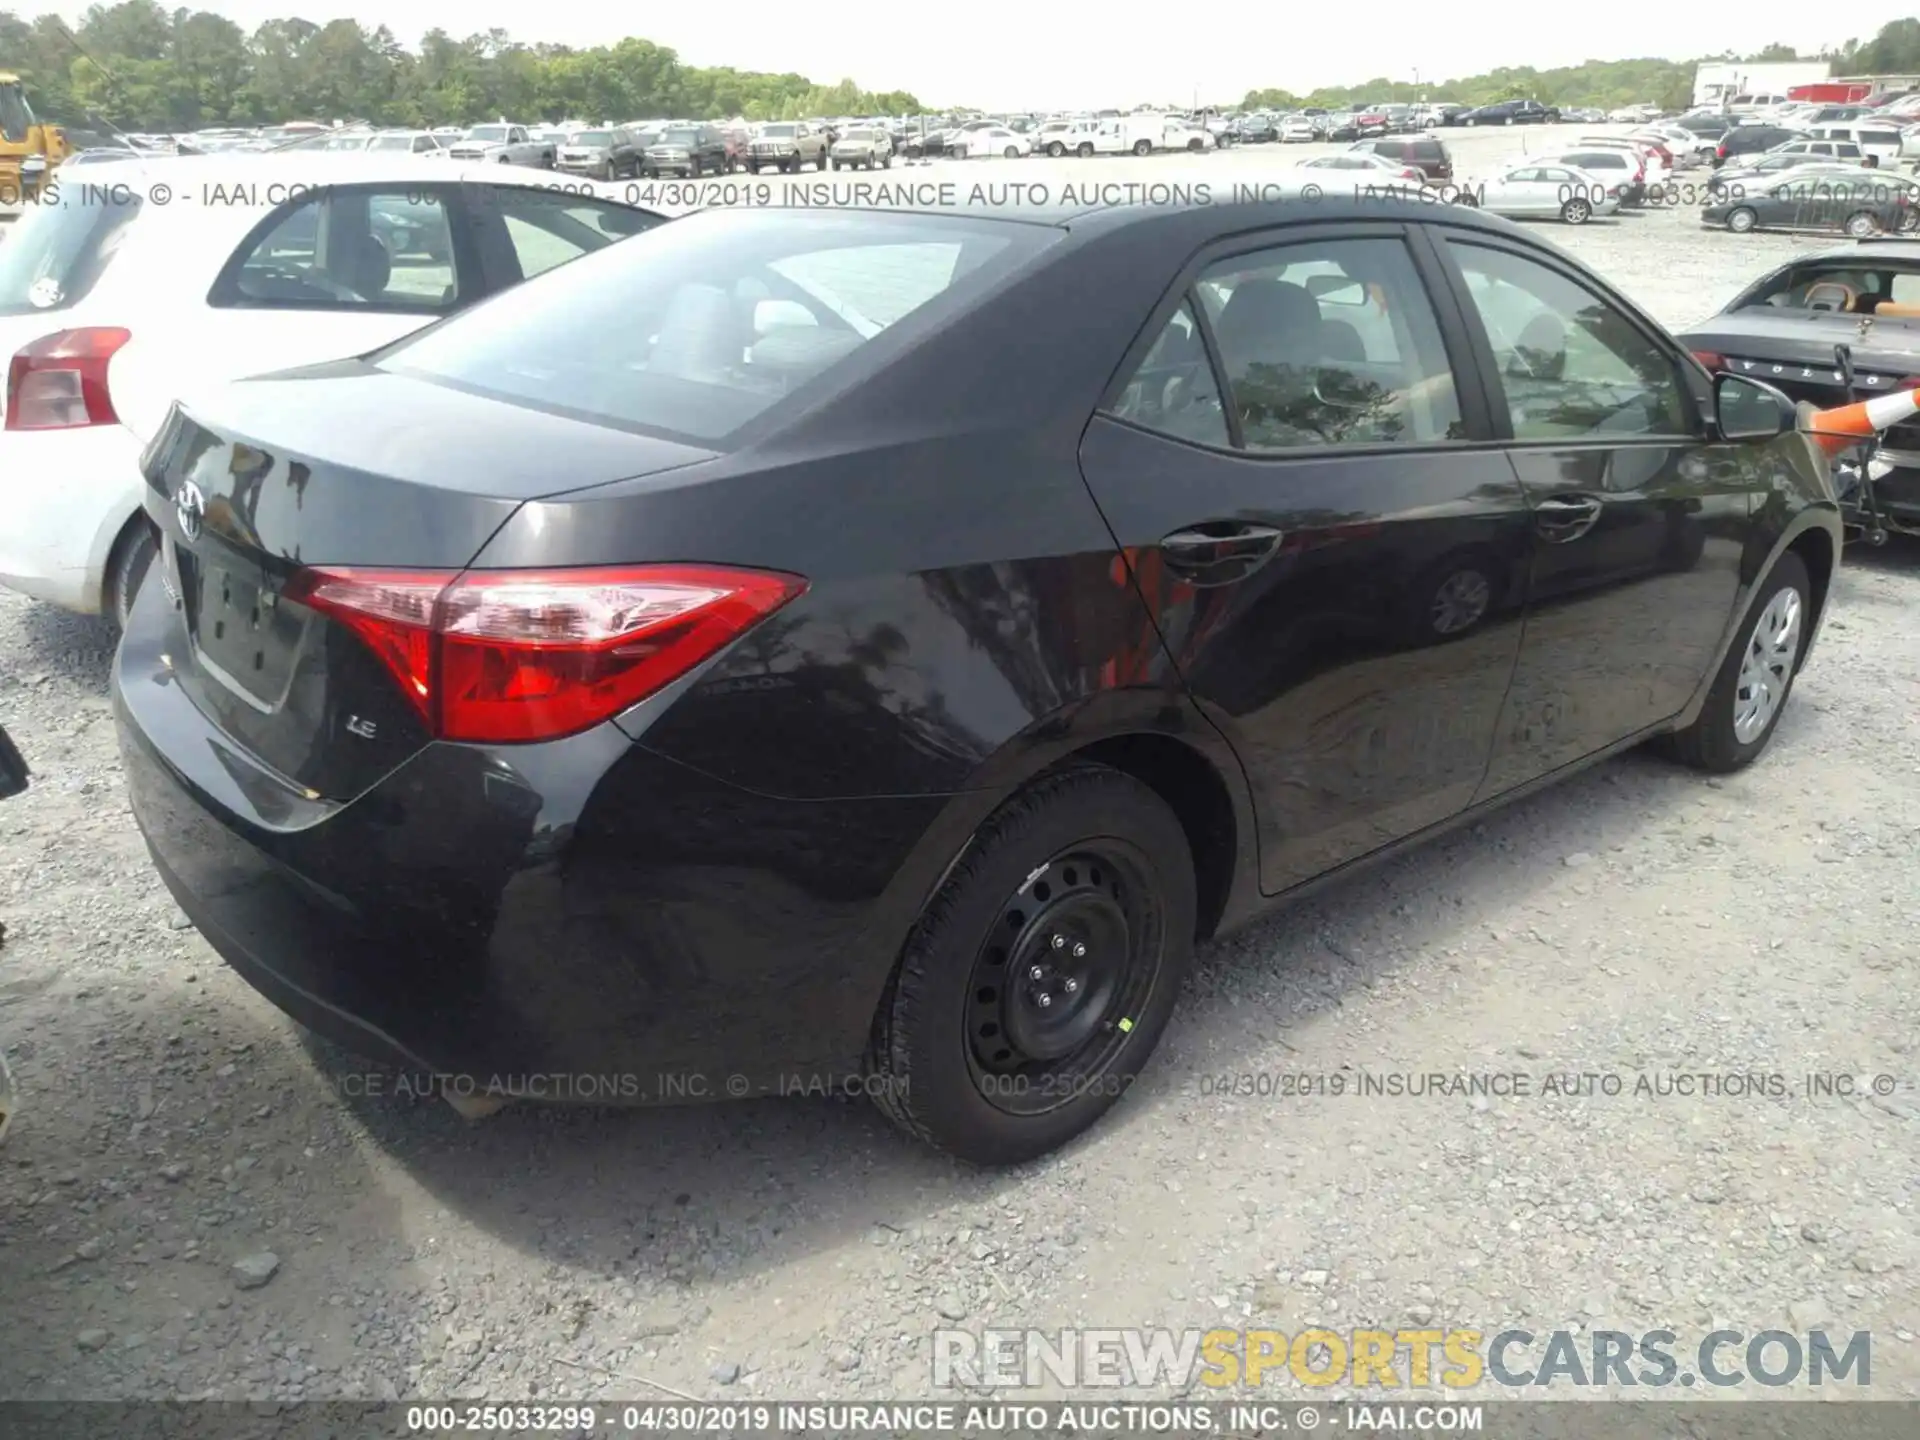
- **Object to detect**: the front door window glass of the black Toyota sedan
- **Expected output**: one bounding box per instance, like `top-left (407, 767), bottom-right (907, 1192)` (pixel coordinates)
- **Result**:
top-left (1448, 240), bottom-right (1692, 440)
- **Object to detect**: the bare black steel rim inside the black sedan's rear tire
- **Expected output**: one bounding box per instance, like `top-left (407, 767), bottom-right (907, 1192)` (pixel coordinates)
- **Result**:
top-left (968, 839), bottom-right (1165, 1116)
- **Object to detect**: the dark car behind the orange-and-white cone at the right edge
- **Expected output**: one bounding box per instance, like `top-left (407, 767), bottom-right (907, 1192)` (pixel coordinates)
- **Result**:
top-left (1682, 240), bottom-right (1920, 536)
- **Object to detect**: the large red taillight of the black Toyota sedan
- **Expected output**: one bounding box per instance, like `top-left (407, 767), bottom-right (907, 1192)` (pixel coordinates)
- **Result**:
top-left (286, 564), bottom-right (806, 743)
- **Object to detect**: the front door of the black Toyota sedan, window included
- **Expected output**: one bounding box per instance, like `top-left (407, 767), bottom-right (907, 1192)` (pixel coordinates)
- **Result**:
top-left (1444, 234), bottom-right (1763, 797)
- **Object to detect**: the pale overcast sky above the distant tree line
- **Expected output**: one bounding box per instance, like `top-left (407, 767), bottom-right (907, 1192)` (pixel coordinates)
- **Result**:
top-left (41, 0), bottom-right (1914, 109)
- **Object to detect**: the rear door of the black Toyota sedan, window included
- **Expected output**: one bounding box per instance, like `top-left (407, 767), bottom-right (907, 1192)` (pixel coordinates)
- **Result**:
top-left (1081, 223), bottom-right (1530, 893)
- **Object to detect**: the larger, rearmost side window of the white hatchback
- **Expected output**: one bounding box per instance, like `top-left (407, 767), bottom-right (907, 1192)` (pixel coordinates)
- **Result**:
top-left (213, 188), bottom-right (461, 311)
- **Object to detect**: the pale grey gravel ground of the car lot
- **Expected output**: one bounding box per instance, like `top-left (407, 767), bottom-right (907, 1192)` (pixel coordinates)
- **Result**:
top-left (0, 180), bottom-right (1920, 1400)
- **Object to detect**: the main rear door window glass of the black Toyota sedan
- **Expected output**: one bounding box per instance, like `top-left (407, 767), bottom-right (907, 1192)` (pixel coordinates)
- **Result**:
top-left (1194, 240), bottom-right (1465, 449)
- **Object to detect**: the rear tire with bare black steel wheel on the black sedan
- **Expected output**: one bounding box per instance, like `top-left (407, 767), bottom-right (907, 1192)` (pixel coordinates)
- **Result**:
top-left (868, 764), bottom-right (1196, 1165)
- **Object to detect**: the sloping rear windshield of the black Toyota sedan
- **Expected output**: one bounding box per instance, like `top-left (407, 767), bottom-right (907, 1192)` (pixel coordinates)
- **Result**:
top-left (380, 211), bottom-right (1060, 442)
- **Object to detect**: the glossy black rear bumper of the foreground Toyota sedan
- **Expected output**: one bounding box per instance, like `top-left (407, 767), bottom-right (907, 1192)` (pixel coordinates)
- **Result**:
top-left (113, 586), bottom-right (947, 1102)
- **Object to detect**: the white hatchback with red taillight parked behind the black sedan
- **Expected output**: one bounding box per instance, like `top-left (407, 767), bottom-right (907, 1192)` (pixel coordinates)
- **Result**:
top-left (0, 154), bottom-right (660, 620)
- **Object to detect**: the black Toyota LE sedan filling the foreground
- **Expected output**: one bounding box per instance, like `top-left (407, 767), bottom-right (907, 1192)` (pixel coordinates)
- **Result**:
top-left (113, 200), bottom-right (1839, 1164)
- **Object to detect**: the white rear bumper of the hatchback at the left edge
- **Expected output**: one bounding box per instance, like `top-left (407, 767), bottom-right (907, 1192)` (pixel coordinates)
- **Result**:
top-left (0, 424), bottom-right (144, 614)
